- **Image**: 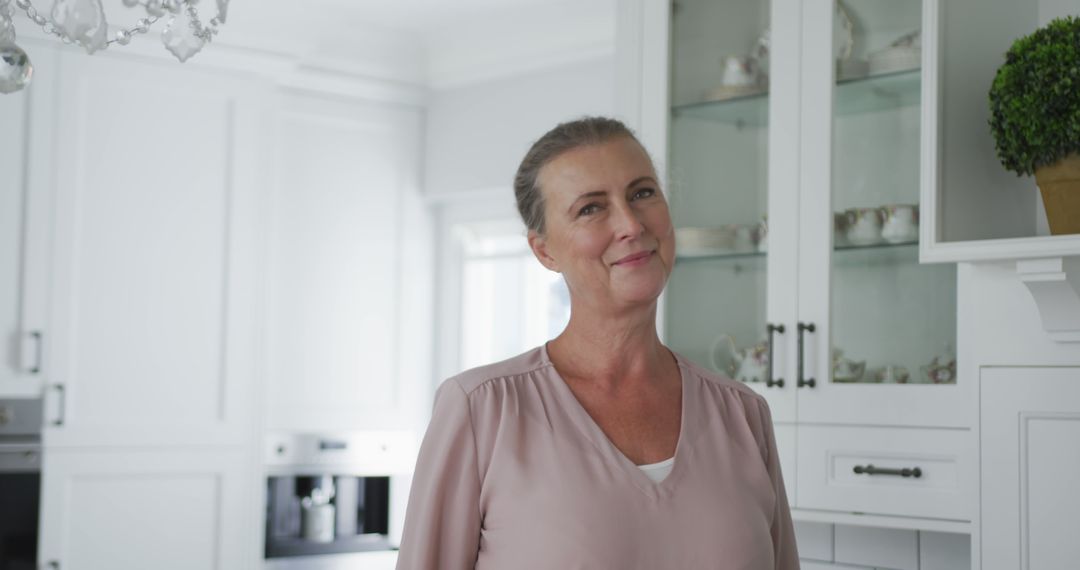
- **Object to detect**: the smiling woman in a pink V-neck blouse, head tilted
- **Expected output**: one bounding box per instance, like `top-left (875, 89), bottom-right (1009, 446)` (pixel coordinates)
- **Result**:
top-left (397, 118), bottom-right (798, 570)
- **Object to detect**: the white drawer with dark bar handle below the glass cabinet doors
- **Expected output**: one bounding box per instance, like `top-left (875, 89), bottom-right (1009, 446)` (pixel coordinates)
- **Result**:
top-left (796, 425), bottom-right (976, 520)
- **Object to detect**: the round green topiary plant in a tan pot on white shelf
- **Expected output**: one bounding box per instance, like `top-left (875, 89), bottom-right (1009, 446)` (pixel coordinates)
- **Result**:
top-left (990, 16), bottom-right (1080, 235)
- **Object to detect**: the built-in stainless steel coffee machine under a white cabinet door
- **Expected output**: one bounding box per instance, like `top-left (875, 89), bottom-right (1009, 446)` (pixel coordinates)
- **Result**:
top-left (264, 432), bottom-right (411, 570)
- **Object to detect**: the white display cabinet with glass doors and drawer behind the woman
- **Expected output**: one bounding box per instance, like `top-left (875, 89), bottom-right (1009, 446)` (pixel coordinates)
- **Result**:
top-left (620, 0), bottom-right (977, 532)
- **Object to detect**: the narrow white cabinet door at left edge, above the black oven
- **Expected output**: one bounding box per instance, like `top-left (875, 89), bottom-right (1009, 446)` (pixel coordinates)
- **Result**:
top-left (0, 46), bottom-right (55, 397)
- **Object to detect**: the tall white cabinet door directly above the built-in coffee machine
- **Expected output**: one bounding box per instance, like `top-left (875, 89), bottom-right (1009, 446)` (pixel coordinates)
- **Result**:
top-left (265, 93), bottom-right (424, 431)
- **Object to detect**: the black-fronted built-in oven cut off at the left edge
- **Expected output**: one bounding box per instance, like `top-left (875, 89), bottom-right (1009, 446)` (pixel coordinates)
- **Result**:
top-left (0, 399), bottom-right (42, 570)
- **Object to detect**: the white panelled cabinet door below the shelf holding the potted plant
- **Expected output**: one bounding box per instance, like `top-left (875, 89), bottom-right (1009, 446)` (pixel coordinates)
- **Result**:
top-left (980, 366), bottom-right (1080, 570)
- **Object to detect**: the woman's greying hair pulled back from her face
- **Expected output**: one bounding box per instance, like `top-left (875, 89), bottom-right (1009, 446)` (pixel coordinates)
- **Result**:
top-left (514, 117), bottom-right (644, 234)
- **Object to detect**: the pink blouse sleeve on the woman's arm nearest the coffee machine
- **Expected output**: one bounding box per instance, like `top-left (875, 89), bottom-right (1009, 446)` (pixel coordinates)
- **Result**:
top-left (397, 379), bottom-right (481, 570)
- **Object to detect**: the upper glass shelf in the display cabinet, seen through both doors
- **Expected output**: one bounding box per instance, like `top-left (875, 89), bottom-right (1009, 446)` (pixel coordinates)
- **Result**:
top-left (672, 68), bottom-right (922, 126)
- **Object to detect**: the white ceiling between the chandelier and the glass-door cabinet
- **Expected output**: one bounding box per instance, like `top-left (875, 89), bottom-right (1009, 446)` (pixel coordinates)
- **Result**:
top-left (217, 0), bottom-right (617, 89)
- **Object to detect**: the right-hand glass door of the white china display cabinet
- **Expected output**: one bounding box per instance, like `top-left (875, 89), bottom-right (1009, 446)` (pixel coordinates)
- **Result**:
top-left (799, 0), bottom-right (957, 425)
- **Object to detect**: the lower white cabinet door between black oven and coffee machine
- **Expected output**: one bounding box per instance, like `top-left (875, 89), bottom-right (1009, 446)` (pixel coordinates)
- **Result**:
top-left (38, 448), bottom-right (258, 570)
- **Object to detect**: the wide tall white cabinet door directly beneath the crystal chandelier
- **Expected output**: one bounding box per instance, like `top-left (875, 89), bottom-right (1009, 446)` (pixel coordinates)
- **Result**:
top-left (41, 52), bottom-right (260, 447)
